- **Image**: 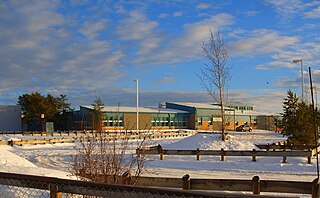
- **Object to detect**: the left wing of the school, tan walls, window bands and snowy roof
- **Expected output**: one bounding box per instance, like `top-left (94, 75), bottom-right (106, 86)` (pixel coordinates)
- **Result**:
top-left (75, 106), bottom-right (190, 131)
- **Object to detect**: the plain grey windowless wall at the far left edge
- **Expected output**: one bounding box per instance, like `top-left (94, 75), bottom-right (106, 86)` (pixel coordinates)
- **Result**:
top-left (0, 105), bottom-right (21, 131)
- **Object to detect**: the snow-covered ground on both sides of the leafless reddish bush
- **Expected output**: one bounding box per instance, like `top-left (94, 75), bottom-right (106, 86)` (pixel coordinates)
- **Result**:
top-left (0, 130), bottom-right (316, 185)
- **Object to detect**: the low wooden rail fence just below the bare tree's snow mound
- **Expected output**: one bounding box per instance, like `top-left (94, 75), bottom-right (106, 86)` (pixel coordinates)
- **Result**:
top-left (136, 145), bottom-right (316, 164)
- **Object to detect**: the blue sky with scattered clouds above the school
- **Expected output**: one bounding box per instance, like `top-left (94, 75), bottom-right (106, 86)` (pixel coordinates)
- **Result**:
top-left (0, 0), bottom-right (320, 113)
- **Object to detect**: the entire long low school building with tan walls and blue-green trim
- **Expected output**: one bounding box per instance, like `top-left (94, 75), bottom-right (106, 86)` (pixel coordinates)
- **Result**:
top-left (74, 102), bottom-right (276, 131)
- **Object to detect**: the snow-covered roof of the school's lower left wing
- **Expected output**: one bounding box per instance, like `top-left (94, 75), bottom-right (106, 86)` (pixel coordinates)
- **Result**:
top-left (81, 106), bottom-right (189, 113)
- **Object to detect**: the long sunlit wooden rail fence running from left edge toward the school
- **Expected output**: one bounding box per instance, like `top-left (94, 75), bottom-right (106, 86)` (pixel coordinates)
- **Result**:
top-left (0, 132), bottom-right (196, 146)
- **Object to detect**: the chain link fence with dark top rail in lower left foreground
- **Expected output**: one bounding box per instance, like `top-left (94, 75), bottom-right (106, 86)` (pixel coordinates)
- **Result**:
top-left (0, 173), bottom-right (218, 198)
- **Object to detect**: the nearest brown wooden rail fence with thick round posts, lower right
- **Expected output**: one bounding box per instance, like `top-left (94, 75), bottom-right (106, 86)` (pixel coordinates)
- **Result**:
top-left (137, 175), bottom-right (319, 197)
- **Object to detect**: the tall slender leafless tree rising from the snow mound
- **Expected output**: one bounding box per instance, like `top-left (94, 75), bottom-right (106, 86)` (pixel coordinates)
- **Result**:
top-left (197, 29), bottom-right (231, 141)
